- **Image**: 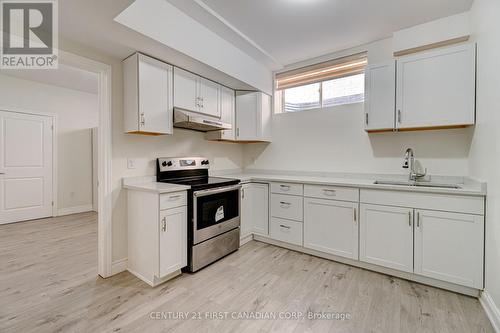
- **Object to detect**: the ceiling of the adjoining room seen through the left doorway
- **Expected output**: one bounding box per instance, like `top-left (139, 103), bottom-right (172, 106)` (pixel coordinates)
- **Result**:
top-left (0, 64), bottom-right (99, 94)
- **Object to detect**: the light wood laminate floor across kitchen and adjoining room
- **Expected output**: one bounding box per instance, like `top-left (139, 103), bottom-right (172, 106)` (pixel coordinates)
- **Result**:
top-left (0, 213), bottom-right (493, 333)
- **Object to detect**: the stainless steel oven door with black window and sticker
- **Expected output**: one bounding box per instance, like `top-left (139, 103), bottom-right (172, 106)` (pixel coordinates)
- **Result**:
top-left (193, 185), bottom-right (241, 244)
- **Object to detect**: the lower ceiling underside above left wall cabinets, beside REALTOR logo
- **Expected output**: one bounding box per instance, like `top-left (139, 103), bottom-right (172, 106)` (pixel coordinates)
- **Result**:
top-left (58, 0), bottom-right (254, 90)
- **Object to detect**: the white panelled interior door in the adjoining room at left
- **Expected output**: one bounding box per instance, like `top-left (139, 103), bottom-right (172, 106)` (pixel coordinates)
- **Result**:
top-left (0, 111), bottom-right (53, 224)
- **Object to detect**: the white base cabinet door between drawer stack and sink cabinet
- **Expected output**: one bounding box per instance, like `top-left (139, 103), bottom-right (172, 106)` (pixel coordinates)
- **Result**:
top-left (304, 198), bottom-right (358, 260)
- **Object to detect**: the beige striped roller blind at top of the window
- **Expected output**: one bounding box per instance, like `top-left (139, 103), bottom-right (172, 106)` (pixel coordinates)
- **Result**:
top-left (276, 52), bottom-right (367, 90)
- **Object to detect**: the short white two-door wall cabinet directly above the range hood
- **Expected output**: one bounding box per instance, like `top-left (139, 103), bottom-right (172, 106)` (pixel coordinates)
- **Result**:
top-left (173, 67), bottom-right (221, 118)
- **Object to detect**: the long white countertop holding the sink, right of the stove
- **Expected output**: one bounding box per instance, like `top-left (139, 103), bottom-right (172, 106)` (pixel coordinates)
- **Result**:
top-left (217, 171), bottom-right (486, 196)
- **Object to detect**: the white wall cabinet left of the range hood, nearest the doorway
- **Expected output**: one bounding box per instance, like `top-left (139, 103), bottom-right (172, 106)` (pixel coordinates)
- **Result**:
top-left (123, 53), bottom-right (173, 135)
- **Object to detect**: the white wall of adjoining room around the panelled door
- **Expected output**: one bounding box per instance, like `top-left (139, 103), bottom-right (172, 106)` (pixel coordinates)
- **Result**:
top-left (0, 75), bottom-right (99, 212)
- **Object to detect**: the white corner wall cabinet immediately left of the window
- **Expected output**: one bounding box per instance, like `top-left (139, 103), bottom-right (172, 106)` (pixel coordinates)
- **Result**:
top-left (236, 91), bottom-right (272, 142)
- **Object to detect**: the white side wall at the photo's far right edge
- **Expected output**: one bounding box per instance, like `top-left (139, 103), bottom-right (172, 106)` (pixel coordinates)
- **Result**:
top-left (470, 0), bottom-right (500, 320)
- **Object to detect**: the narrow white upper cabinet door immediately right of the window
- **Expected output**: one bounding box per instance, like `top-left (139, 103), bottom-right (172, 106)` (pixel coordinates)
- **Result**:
top-left (365, 60), bottom-right (396, 131)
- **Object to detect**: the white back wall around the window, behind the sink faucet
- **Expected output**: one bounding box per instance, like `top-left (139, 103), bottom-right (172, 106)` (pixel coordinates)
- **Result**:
top-left (244, 39), bottom-right (473, 176)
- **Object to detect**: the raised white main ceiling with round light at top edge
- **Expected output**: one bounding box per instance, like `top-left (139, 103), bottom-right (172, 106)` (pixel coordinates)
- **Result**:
top-left (198, 0), bottom-right (473, 65)
